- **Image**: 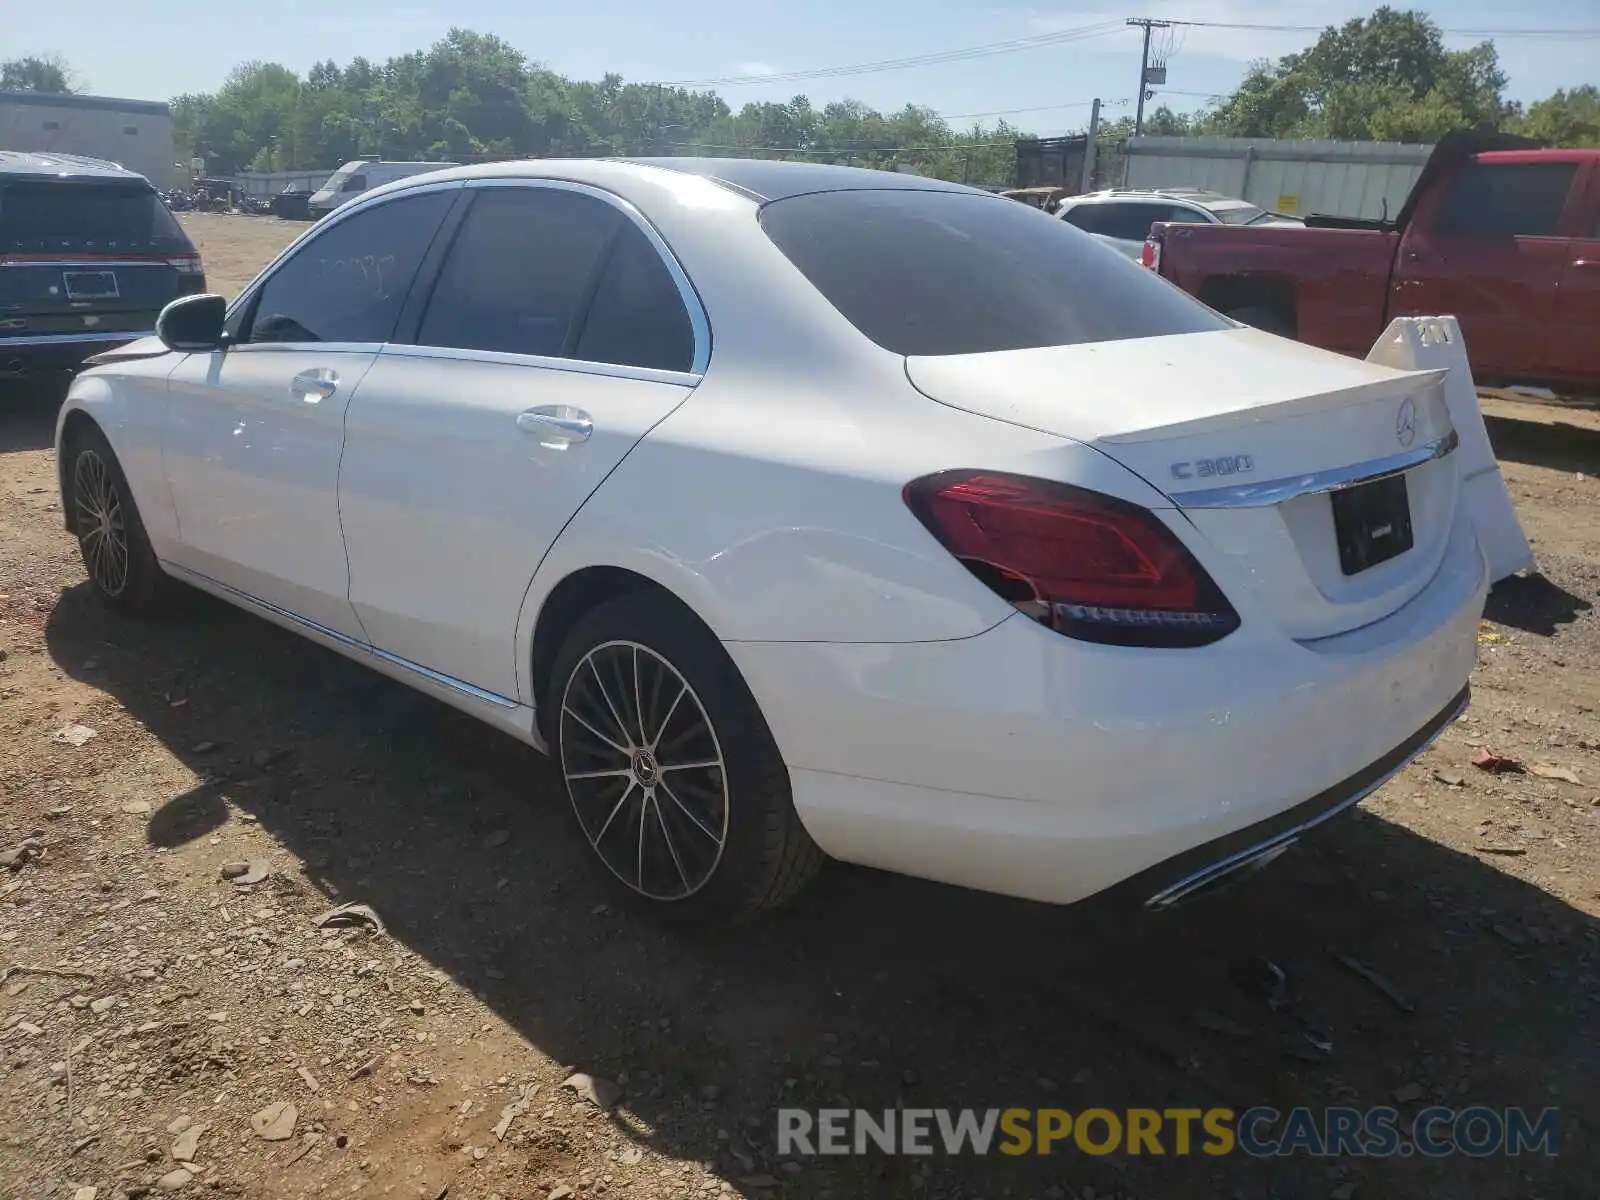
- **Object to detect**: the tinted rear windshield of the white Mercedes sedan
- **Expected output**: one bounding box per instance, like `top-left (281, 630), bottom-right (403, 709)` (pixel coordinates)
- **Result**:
top-left (760, 190), bottom-right (1234, 355)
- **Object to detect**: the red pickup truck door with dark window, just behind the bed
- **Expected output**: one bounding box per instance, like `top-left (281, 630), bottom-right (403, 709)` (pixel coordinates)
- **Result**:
top-left (1389, 154), bottom-right (1581, 382)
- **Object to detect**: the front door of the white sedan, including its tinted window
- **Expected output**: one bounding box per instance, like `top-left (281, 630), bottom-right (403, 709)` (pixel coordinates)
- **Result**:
top-left (162, 190), bottom-right (458, 640)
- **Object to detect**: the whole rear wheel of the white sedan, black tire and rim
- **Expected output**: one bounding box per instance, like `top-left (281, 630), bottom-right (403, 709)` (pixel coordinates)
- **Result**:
top-left (544, 592), bottom-right (824, 925)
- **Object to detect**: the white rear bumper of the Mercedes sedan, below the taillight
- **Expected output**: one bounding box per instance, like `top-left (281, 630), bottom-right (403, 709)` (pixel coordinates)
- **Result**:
top-left (728, 518), bottom-right (1488, 902)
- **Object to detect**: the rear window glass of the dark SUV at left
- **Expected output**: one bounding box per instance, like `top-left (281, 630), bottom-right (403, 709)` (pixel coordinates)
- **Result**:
top-left (0, 182), bottom-right (192, 254)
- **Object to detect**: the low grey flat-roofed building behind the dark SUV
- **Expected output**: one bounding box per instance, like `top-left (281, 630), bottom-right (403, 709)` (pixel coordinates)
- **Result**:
top-left (0, 91), bottom-right (178, 187)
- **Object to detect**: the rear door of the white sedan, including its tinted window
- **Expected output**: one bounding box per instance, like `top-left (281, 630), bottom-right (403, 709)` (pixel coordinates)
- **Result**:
top-left (339, 181), bottom-right (709, 702)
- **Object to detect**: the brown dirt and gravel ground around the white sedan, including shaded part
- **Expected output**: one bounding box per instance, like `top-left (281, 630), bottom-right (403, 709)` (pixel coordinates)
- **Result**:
top-left (0, 214), bottom-right (1600, 1200)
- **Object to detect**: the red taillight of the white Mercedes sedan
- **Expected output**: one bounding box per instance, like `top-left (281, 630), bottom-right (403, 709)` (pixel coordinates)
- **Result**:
top-left (904, 470), bottom-right (1238, 646)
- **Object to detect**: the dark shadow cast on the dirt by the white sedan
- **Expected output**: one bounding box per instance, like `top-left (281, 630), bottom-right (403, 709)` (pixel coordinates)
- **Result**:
top-left (46, 586), bottom-right (1600, 1200)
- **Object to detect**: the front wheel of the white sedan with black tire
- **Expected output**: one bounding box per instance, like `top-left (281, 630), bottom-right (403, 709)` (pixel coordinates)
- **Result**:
top-left (62, 426), bottom-right (184, 616)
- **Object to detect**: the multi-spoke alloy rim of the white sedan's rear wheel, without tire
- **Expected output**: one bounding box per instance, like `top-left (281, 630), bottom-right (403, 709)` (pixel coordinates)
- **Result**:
top-left (560, 642), bottom-right (728, 901)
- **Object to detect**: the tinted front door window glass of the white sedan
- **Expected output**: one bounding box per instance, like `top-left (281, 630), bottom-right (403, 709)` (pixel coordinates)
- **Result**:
top-left (243, 190), bottom-right (456, 342)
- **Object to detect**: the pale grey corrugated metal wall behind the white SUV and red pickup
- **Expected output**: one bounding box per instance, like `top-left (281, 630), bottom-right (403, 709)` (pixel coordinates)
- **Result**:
top-left (1125, 138), bottom-right (1434, 219)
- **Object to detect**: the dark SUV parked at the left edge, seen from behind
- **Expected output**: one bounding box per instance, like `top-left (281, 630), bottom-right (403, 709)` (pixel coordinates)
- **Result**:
top-left (0, 150), bottom-right (205, 387)
